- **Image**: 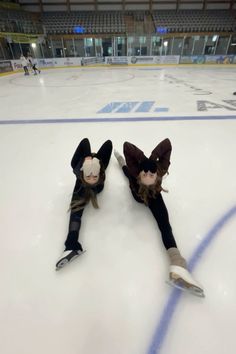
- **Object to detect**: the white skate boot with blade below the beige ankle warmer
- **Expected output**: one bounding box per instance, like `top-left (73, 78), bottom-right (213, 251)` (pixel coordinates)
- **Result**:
top-left (168, 265), bottom-right (205, 297)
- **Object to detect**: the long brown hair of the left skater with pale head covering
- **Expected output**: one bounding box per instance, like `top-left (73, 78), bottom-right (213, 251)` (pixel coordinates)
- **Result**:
top-left (69, 163), bottom-right (105, 212)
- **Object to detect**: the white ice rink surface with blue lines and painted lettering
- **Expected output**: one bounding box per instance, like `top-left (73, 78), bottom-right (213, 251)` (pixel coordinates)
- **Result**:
top-left (0, 65), bottom-right (236, 354)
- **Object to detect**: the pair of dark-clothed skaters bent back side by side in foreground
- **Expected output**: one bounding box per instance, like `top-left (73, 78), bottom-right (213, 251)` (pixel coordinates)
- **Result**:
top-left (56, 138), bottom-right (204, 296)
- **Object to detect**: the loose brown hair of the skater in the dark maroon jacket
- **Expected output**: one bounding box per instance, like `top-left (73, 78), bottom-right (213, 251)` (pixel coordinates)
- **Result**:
top-left (137, 171), bottom-right (168, 205)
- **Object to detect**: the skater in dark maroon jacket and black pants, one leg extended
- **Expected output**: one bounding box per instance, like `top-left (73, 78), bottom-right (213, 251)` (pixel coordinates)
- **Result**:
top-left (114, 139), bottom-right (204, 297)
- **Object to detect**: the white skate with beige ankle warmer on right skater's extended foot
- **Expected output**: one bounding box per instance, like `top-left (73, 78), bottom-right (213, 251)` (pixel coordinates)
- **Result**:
top-left (167, 247), bottom-right (205, 297)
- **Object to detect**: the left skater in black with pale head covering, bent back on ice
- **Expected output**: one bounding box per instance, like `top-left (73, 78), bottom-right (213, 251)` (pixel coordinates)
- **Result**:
top-left (56, 138), bottom-right (112, 270)
